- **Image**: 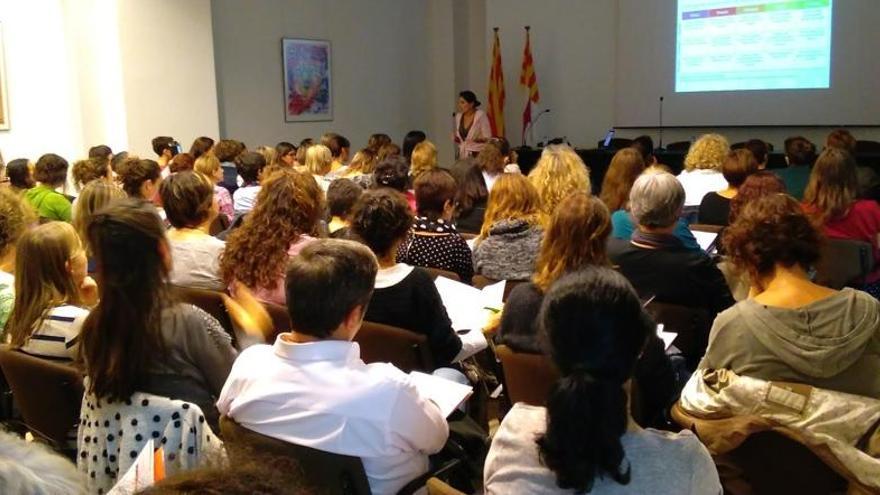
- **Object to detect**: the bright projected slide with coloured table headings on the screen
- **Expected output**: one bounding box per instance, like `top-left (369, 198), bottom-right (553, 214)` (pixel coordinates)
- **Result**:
top-left (675, 0), bottom-right (832, 92)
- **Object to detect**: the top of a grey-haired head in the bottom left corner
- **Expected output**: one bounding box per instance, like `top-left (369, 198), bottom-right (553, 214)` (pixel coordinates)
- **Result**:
top-left (0, 431), bottom-right (86, 495)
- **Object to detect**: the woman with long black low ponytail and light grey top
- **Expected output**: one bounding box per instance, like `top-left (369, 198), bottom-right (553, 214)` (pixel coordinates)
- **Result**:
top-left (483, 267), bottom-right (721, 495)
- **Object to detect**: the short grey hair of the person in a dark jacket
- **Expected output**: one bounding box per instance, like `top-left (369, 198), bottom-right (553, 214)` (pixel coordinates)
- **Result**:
top-left (629, 172), bottom-right (684, 228)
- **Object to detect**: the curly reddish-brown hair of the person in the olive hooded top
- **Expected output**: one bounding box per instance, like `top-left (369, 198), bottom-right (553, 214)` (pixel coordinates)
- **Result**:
top-left (721, 193), bottom-right (822, 281)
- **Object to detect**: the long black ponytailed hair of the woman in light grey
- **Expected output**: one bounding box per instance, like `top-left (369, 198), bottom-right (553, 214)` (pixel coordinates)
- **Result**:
top-left (537, 266), bottom-right (653, 493)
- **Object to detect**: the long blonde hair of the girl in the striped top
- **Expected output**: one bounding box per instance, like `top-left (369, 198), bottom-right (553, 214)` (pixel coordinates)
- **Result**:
top-left (6, 222), bottom-right (82, 348)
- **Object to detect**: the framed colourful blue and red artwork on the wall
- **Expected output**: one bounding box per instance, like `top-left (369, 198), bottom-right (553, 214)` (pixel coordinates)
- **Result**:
top-left (281, 38), bottom-right (333, 122)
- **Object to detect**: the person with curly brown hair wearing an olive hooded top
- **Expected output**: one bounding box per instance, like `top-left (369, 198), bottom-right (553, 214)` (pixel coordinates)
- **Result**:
top-left (699, 194), bottom-right (880, 399)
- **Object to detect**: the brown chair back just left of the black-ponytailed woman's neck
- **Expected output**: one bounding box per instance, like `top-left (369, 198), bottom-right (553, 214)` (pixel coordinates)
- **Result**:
top-left (495, 345), bottom-right (559, 406)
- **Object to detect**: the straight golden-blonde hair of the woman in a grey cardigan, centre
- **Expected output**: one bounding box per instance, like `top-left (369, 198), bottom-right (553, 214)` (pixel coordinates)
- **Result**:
top-left (479, 174), bottom-right (546, 241)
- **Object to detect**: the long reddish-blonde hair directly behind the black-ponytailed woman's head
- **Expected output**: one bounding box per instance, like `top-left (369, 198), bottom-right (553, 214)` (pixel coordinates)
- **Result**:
top-left (532, 192), bottom-right (611, 292)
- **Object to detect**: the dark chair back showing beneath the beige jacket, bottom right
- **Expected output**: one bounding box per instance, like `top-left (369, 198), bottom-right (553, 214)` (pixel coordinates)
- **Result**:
top-left (715, 430), bottom-right (847, 495)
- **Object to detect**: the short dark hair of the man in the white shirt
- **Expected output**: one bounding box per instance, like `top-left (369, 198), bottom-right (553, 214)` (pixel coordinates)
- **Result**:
top-left (284, 239), bottom-right (379, 339)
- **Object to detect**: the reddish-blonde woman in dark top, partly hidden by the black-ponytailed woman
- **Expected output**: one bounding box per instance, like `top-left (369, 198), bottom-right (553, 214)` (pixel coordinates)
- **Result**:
top-left (497, 192), bottom-right (676, 425)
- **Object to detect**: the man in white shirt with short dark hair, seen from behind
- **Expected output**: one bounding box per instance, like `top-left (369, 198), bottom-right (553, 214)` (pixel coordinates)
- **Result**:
top-left (217, 240), bottom-right (449, 494)
